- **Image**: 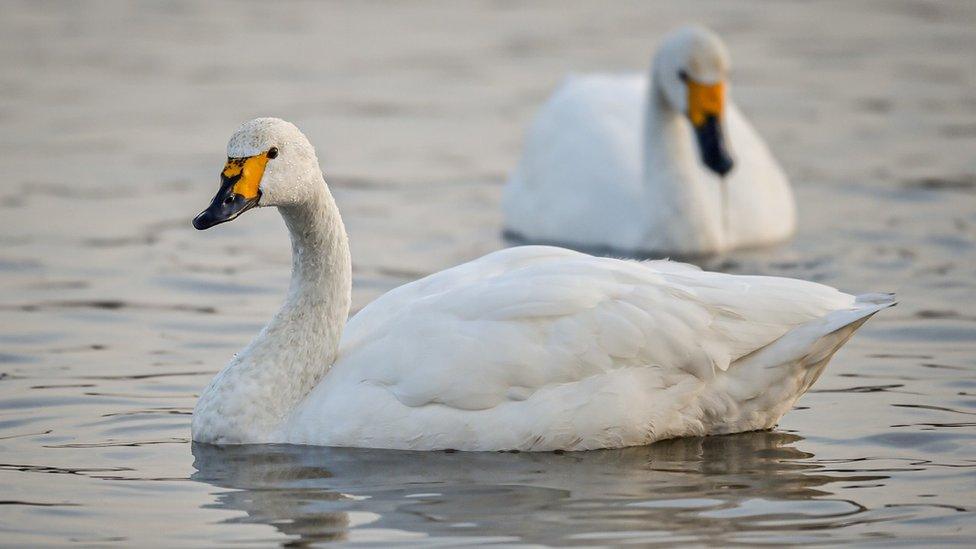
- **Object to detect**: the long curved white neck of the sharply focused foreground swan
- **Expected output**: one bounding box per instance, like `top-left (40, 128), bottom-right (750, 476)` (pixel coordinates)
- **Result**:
top-left (192, 170), bottom-right (352, 442)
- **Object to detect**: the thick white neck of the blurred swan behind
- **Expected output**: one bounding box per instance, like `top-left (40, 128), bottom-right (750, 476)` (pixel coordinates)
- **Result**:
top-left (643, 71), bottom-right (723, 253)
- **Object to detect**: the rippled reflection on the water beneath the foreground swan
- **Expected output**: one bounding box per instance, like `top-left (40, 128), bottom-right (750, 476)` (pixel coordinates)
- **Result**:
top-left (192, 432), bottom-right (887, 544)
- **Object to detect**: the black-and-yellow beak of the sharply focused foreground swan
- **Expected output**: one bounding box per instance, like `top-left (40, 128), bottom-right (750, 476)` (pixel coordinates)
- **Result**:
top-left (193, 153), bottom-right (268, 231)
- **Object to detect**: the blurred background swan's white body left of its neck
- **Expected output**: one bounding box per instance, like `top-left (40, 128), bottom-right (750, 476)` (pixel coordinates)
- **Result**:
top-left (502, 75), bottom-right (647, 244)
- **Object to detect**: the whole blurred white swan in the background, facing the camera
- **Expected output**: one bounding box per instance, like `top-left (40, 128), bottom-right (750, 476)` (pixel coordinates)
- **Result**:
top-left (502, 27), bottom-right (796, 257)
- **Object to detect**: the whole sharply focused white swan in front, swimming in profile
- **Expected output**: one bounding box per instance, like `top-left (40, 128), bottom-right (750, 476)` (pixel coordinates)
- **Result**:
top-left (191, 118), bottom-right (894, 450)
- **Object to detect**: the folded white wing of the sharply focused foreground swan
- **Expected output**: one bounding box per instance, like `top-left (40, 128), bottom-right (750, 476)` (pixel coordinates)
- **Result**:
top-left (328, 246), bottom-right (854, 410)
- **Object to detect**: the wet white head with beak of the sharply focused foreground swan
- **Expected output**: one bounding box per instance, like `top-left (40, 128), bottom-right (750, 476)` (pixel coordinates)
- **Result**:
top-left (193, 118), bottom-right (323, 231)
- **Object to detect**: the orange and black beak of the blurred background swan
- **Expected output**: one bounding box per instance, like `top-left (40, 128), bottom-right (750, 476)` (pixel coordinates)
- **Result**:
top-left (685, 78), bottom-right (733, 177)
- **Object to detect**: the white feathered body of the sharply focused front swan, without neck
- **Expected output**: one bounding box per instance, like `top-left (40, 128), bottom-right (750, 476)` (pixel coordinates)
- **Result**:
top-left (276, 247), bottom-right (880, 450)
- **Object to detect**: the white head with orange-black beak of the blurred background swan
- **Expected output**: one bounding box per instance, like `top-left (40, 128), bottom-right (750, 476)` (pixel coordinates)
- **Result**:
top-left (652, 27), bottom-right (733, 176)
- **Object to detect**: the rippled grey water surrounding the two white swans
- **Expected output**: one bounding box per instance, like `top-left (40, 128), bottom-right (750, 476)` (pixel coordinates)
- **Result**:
top-left (0, 0), bottom-right (976, 546)
